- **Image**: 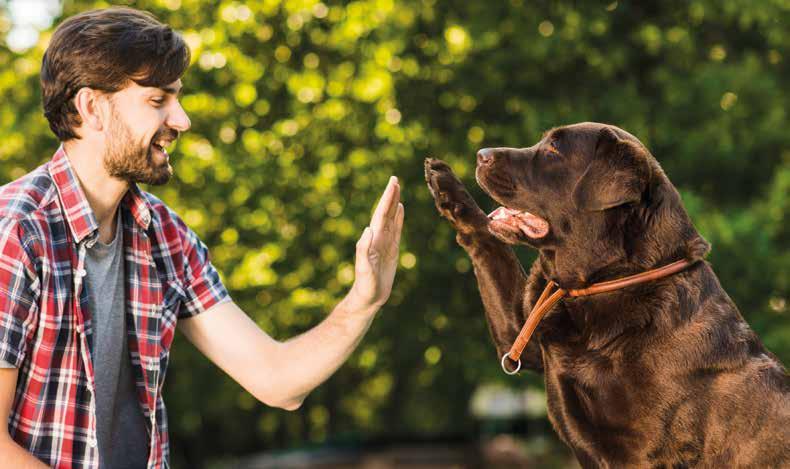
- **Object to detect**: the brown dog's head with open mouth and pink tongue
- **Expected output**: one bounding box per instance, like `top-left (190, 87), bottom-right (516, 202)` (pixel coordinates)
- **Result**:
top-left (476, 122), bottom-right (708, 288)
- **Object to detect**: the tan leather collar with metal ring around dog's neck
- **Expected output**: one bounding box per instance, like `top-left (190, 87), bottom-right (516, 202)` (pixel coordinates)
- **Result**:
top-left (502, 259), bottom-right (697, 375)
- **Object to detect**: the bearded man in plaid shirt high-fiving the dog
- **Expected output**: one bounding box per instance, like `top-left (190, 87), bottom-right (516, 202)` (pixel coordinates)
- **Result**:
top-left (0, 8), bottom-right (403, 468)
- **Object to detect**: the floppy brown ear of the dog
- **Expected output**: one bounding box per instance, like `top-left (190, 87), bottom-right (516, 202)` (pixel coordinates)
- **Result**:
top-left (573, 127), bottom-right (650, 212)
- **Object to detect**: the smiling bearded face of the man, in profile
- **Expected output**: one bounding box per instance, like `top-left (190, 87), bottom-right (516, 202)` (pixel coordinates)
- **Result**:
top-left (104, 80), bottom-right (190, 185)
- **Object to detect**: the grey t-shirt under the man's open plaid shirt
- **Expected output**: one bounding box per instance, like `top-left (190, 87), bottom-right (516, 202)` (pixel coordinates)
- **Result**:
top-left (85, 211), bottom-right (148, 469)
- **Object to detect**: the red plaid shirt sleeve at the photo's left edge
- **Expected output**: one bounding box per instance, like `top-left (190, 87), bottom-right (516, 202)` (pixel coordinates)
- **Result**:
top-left (0, 218), bottom-right (38, 368)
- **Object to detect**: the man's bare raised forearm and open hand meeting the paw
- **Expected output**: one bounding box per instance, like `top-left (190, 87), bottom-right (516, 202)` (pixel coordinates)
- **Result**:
top-left (178, 178), bottom-right (403, 410)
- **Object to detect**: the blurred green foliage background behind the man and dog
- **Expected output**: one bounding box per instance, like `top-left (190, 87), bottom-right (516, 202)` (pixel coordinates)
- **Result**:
top-left (0, 0), bottom-right (790, 468)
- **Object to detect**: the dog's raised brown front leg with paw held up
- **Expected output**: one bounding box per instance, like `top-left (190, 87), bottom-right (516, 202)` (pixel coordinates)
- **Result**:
top-left (425, 158), bottom-right (543, 370)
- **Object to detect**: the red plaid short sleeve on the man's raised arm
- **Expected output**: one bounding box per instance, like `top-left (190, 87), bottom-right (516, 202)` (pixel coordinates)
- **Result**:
top-left (174, 212), bottom-right (231, 319)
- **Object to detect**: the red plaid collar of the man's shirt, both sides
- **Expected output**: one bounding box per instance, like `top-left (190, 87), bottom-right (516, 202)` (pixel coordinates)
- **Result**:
top-left (49, 145), bottom-right (151, 244)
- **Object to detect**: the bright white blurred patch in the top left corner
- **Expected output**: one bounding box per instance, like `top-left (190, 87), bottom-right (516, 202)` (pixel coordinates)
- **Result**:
top-left (0, 0), bottom-right (61, 52)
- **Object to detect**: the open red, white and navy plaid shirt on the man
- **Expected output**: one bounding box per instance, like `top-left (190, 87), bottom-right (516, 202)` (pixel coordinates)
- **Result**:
top-left (0, 147), bottom-right (229, 468)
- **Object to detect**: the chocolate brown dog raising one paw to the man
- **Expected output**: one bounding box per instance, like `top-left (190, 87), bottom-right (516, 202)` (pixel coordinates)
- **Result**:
top-left (425, 123), bottom-right (790, 469)
